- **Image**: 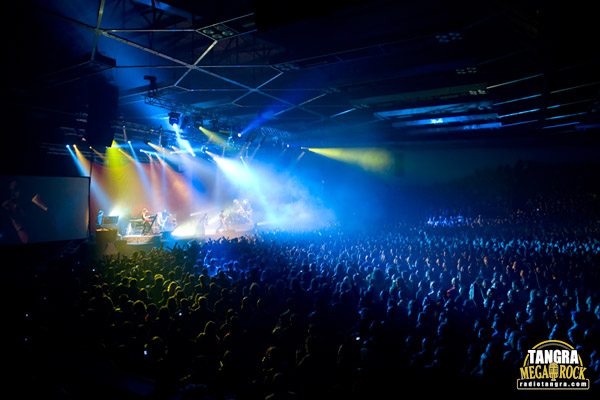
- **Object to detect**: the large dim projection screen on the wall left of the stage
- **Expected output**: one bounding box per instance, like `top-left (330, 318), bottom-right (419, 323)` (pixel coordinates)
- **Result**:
top-left (0, 175), bottom-right (90, 245)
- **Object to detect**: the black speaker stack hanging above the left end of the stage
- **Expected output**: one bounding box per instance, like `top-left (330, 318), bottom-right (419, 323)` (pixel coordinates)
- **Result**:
top-left (86, 80), bottom-right (119, 147)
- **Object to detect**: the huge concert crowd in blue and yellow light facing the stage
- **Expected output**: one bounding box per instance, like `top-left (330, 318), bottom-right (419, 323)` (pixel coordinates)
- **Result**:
top-left (15, 162), bottom-right (600, 400)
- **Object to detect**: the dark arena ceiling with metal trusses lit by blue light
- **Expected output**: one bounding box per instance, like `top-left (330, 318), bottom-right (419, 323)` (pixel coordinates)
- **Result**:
top-left (3, 0), bottom-right (600, 155)
